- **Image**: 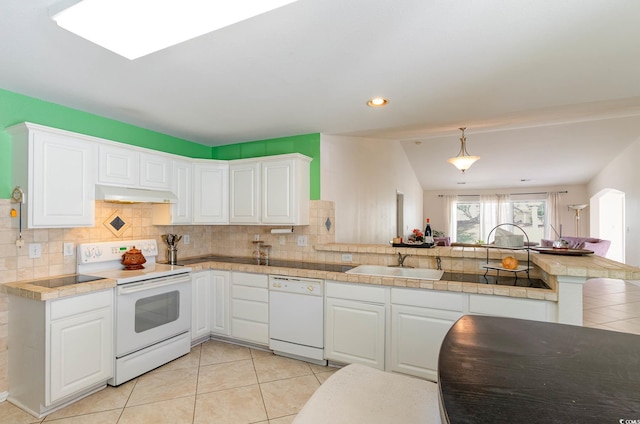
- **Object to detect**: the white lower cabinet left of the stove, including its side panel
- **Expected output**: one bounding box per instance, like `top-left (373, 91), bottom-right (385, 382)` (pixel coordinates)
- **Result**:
top-left (9, 289), bottom-right (114, 416)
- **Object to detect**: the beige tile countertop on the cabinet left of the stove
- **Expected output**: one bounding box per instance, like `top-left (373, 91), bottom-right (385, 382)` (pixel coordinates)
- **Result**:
top-left (0, 274), bottom-right (116, 301)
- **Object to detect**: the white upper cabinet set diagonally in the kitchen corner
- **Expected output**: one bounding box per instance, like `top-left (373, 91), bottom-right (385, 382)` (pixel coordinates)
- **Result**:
top-left (193, 160), bottom-right (229, 224)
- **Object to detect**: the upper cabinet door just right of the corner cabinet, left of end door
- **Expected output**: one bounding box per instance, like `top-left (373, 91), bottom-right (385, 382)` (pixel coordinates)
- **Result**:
top-left (229, 162), bottom-right (260, 224)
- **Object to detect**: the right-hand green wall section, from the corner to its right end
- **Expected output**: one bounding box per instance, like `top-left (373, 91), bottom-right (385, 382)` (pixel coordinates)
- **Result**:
top-left (211, 133), bottom-right (320, 200)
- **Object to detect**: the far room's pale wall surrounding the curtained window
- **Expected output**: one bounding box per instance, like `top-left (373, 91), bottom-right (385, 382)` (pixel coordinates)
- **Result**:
top-left (423, 185), bottom-right (589, 242)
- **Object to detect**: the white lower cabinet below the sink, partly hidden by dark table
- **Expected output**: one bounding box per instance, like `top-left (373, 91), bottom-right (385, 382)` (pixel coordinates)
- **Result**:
top-left (388, 287), bottom-right (466, 381)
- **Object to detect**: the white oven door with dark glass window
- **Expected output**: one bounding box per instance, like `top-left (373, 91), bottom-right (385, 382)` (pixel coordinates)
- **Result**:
top-left (116, 274), bottom-right (191, 358)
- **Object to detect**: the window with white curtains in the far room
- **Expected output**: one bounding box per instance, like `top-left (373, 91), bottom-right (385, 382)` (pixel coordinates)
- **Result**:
top-left (451, 196), bottom-right (547, 244)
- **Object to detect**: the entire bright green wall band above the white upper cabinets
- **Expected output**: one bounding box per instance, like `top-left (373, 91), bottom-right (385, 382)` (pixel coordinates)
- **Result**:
top-left (0, 88), bottom-right (320, 200)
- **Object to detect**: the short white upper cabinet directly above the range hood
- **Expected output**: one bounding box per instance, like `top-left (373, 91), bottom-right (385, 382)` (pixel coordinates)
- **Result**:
top-left (98, 143), bottom-right (172, 190)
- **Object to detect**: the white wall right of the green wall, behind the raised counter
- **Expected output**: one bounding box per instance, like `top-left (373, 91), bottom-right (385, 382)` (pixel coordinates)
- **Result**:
top-left (320, 134), bottom-right (423, 244)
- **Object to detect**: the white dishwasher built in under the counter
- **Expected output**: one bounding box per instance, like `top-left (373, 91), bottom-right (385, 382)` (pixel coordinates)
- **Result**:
top-left (269, 275), bottom-right (327, 365)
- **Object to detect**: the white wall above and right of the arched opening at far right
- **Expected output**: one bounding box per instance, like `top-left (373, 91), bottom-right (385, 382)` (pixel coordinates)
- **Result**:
top-left (587, 139), bottom-right (640, 266)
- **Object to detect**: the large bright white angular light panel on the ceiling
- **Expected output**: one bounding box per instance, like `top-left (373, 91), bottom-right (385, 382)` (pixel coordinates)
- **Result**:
top-left (49, 0), bottom-right (296, 60)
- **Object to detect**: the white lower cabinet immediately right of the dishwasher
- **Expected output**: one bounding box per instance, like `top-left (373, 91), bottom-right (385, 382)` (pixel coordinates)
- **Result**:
top-left (325, 282), bottom-right (388, 370)
